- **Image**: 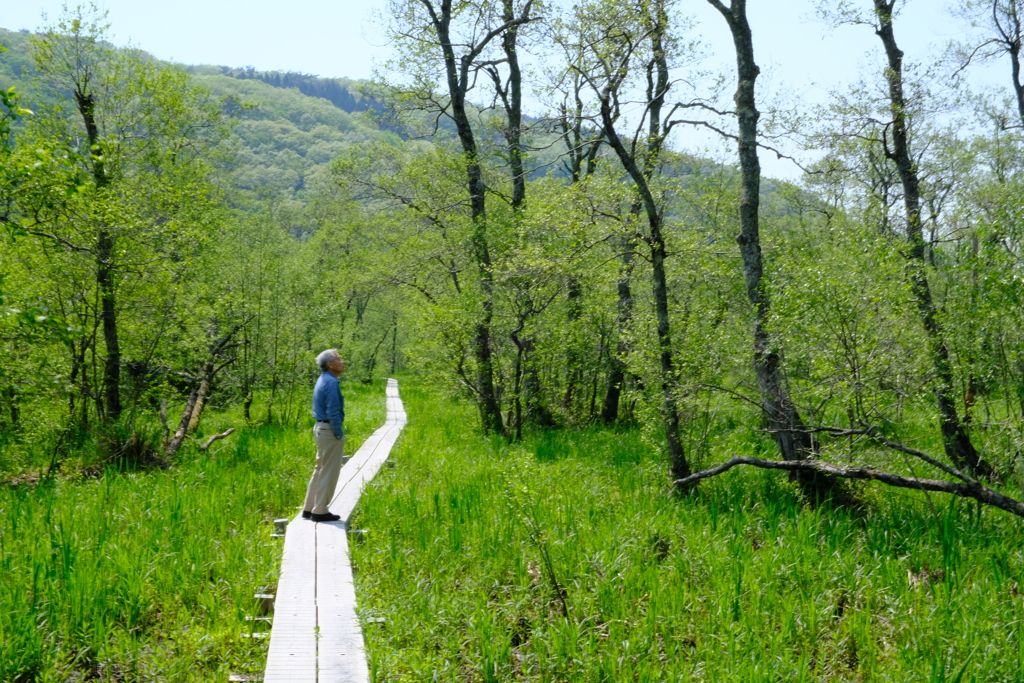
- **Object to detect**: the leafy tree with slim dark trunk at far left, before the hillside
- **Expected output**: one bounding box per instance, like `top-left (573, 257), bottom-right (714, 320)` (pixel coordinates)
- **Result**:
top-left (18, 8), bottom-right (220, 432)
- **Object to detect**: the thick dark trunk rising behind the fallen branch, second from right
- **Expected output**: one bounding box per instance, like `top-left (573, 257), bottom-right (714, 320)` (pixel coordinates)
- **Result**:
top-left (709, 0), bottom-right (815, 476)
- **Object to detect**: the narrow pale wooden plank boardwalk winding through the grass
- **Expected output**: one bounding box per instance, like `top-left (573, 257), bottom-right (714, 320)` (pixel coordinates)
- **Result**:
top-left (263, 380), bottom-right (406, 683)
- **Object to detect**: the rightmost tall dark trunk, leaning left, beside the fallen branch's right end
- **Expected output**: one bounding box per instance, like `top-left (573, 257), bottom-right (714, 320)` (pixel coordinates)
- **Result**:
top-left (874, 0), bottom-right (993, 477)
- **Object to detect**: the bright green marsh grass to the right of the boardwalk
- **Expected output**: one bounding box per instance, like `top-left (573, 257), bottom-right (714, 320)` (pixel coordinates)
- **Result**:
top-left (352, 381), bottom-right (1024, 682)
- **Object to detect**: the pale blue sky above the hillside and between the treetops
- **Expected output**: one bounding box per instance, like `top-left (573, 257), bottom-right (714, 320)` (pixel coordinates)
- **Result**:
top-left (0, 0), bottom-right (1010, 177)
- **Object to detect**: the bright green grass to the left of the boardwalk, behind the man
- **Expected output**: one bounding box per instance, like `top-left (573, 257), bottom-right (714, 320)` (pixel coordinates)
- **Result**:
top-left (0, 382), bottom-right (384, 683)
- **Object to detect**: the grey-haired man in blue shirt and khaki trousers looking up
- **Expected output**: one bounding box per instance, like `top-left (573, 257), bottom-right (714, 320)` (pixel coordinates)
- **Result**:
top-left (302, 348), bottom-right (345, 522)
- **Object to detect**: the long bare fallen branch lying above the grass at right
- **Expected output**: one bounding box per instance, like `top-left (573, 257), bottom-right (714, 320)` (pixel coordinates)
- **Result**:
top-left (675, 456), bottom-right (1024, 517)
